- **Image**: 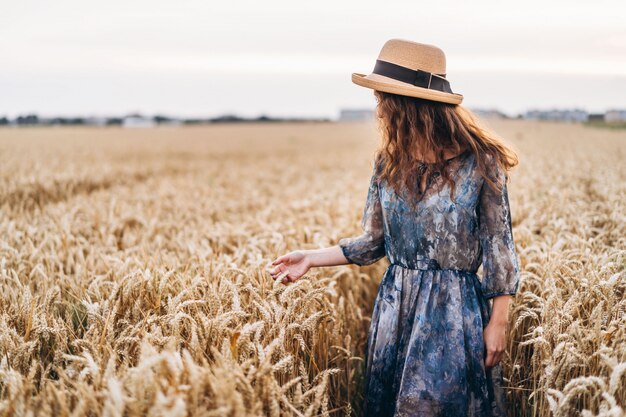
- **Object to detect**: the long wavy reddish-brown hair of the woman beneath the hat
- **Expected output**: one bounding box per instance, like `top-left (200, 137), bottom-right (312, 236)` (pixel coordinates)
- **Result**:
top-left (374, 90), bottom-right (519, 210)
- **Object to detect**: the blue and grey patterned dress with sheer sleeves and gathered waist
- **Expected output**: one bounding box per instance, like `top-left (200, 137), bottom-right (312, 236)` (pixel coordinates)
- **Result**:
top-left (338, 152), bottom-right (520, 417)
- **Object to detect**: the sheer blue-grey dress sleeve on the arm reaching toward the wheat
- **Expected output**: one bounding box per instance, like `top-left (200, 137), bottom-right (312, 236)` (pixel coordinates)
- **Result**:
top-left (338, 158), bottom-right (385, 265)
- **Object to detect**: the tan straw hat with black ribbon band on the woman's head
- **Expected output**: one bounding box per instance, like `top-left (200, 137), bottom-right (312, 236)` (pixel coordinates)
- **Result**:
top-left (352, 39), bottom-right (463, 104)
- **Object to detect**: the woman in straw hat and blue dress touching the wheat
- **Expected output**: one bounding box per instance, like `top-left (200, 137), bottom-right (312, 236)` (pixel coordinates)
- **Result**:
top-left (270, 39), bottom-right (519, 417)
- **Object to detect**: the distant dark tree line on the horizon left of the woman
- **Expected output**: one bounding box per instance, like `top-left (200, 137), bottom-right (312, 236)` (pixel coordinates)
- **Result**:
top-left (0, 114), bottom-right (330, 126)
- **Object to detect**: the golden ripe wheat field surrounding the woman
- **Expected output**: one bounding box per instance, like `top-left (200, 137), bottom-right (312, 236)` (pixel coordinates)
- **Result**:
top-left (0, 120), bottom-right (626, 417)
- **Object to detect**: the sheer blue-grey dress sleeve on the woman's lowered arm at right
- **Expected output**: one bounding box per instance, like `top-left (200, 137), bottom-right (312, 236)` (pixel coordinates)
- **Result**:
top-left (478, 157), bottom-right (520, 298)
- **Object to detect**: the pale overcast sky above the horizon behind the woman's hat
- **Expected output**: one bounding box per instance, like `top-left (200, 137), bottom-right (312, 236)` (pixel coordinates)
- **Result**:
top-left (0, 0), bottom-right (626, 118)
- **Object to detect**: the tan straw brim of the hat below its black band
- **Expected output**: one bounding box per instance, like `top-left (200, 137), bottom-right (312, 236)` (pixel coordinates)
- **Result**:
top-left (352, 72), bottom-right (463, 104)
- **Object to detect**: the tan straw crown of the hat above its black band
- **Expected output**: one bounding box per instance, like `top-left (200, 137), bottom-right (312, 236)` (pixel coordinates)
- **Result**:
top-left (378, 39), bottom-right (446, 76)
